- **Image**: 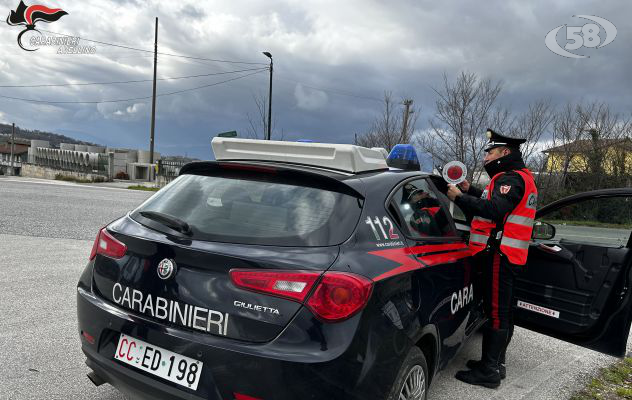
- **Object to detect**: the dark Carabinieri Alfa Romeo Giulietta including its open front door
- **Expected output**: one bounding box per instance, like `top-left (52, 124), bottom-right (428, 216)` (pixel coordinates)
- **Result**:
top-left (77, 138), bottom-right (632, 400)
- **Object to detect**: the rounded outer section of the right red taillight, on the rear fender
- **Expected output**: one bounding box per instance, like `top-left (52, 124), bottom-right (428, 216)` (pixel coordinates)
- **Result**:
top-left (307, 272), bottom-right (373, 322)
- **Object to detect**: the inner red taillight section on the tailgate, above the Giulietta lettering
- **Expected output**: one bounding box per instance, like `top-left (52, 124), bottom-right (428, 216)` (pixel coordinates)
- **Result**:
top-left (230, 269), bottom-right (320, 302)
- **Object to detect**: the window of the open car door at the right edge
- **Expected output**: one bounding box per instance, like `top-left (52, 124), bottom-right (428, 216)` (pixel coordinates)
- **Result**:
top-left (540, 197), bottom-right (632, 247)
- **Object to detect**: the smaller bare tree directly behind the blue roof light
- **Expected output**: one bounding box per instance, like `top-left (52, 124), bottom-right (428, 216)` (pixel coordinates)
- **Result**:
top-left (356, 92), bottom-right (419, 151)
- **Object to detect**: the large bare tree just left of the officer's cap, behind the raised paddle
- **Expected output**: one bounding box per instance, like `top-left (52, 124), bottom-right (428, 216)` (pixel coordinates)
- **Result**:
top-left (416, 72), bottom-right (513, 180)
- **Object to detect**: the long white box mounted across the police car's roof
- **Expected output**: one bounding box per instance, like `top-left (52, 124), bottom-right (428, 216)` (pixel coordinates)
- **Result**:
top-left (211, 137), bottom-right (388, 173)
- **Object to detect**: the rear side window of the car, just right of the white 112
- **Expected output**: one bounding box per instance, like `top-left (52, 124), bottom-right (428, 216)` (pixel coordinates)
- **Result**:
top-left (391, 179), bottom-right (455, 238)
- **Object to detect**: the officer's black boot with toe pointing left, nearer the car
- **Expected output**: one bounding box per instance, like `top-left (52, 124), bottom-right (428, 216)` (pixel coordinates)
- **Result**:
top-left (455, 329), bottom-right (507, 389)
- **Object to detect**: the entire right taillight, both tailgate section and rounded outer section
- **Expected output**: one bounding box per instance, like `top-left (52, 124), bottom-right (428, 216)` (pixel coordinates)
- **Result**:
top-left (230, 269), bottom-right (373, 322)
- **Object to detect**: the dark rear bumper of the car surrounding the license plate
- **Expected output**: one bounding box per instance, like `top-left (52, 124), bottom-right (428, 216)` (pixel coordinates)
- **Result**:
top-left (77, 285), bottom-right (397, 400)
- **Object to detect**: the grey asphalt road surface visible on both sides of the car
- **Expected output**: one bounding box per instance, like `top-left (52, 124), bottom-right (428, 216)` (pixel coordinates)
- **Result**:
top-left (0, 178), bottom-right (628, 400)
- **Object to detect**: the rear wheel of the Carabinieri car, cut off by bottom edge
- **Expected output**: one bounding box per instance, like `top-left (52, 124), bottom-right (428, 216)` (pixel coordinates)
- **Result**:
top-left (387, 346), bottom-right (428, 400)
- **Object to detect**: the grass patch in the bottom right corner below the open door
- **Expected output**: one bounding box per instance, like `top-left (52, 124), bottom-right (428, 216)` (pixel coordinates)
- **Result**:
top-left (571, 357), bottom-right (632, 400)
